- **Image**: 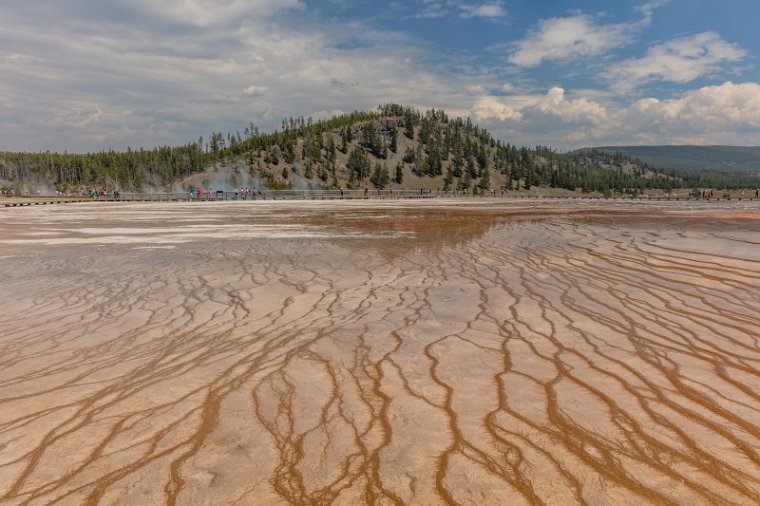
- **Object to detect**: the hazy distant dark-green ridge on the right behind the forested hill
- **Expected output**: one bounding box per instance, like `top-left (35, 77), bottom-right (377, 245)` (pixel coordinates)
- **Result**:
top-left (579, 145), bottom-right (760, 174)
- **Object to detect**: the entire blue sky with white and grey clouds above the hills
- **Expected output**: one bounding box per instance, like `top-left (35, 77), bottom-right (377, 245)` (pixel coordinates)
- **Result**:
top-left (0, 0), bottom-right (760, 152)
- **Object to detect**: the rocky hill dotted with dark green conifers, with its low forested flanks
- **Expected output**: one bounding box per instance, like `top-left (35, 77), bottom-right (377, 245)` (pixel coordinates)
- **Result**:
top-left (0, 104), bottom-right (760, 193)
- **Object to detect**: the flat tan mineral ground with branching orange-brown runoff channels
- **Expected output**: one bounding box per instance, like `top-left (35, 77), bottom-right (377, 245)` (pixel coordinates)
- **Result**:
top-left (0, 201), bottom-right (760, 504)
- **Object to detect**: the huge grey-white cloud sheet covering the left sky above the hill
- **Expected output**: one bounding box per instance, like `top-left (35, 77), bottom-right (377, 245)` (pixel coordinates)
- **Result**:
top-left (0, 0), bottom-right (480, 151)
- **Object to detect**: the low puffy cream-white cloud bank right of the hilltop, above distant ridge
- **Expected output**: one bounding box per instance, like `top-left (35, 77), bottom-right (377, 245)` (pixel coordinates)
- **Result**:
top-left (471, 82), bottom-right (760, 149)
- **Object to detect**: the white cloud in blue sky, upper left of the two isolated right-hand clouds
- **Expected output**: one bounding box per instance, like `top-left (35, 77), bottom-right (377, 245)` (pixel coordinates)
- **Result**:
top-left (509, 14), bottom-right (635, 67)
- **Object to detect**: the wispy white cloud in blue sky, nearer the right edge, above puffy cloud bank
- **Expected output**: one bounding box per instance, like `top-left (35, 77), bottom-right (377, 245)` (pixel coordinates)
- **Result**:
top-left (606, 32), bottom-right (747, 91)
